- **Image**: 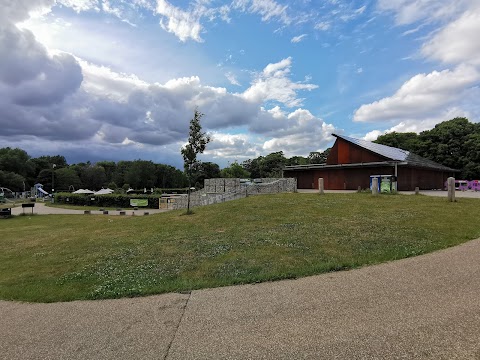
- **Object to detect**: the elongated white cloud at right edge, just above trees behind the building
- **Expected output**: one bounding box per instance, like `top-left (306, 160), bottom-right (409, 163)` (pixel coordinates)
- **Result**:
top-left (354, 65), bottom-right (480, 122)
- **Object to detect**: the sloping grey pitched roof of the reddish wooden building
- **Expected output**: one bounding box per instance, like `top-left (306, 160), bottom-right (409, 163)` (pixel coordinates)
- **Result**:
top-left (332, 134), bottom-right (458, 171)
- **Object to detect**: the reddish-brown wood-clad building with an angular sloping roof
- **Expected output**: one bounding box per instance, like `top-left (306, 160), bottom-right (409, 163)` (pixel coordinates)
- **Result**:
top-left (284, 134), bottom-right (458, 191)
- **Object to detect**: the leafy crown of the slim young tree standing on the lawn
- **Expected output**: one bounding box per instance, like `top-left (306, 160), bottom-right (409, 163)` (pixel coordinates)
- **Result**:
top-left (181, 109), bottom-right (210, 185)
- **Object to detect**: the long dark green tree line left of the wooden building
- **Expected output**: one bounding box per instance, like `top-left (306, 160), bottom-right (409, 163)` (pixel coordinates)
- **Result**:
top-left (0, 147), bottom-right (325, 192)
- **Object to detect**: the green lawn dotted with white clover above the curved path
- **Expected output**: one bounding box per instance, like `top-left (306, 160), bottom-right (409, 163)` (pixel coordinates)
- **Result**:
top-left (0, 194), bottom-right (480, 302)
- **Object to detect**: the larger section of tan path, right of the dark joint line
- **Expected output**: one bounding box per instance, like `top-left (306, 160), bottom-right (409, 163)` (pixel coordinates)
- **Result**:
top-left (167, 240), bottom-right (480, 360)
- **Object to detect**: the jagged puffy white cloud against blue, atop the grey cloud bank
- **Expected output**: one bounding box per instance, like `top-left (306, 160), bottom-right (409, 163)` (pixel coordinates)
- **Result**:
top-left (242, 58), bottom-right (318, 107)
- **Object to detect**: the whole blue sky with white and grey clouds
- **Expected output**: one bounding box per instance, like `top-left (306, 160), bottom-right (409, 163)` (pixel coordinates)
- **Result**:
top-left (0, 0), bottom-right (480, 168)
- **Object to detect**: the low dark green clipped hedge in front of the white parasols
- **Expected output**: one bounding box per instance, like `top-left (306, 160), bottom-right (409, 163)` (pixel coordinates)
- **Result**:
top-left (55, 193), bottom-right (161, 209)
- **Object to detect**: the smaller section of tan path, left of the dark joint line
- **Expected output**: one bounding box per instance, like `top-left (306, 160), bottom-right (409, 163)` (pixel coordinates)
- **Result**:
top-left (0, 294), bottom-right (188, 360)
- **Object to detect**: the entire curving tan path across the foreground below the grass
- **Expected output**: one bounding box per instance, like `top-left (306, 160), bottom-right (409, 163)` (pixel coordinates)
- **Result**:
top-left (0, 239), bottom-right (480, 360)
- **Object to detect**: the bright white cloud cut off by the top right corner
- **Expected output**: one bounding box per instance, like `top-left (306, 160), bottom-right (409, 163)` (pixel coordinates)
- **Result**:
top-left (422, 6), bottom-right (480, 65)
